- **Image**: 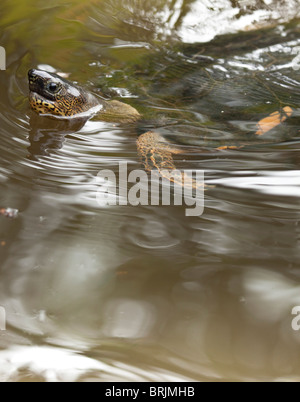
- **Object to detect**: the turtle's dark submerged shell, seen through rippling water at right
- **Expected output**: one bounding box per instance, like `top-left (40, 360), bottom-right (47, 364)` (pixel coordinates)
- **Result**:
top-left (134, 25), bottom-right (300, 147)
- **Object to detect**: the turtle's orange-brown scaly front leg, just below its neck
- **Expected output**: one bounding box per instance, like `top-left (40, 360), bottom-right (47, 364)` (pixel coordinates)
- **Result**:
top-left (137, 131), bottom-right (203, 189)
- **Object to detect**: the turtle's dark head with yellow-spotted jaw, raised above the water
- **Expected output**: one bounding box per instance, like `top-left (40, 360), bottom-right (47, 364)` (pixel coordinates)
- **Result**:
top-left (28, 70), bottom-right (99, 117)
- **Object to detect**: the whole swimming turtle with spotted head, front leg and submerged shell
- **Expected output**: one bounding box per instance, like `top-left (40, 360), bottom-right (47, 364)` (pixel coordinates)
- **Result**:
top-left (28, 27), bottom-right (300, 184)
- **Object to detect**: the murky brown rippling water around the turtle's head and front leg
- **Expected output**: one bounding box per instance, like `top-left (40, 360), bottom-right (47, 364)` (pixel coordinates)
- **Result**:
top-left (0, 0), bottom-right (300, 381)
